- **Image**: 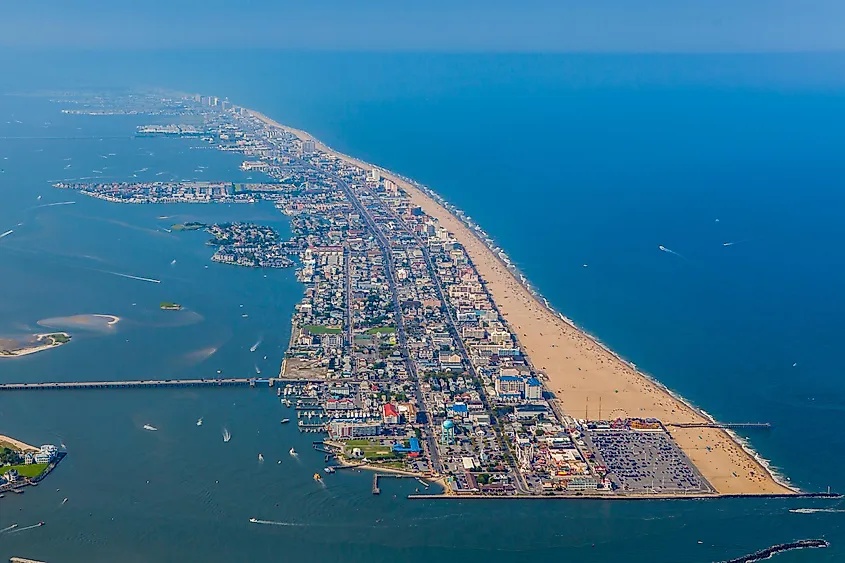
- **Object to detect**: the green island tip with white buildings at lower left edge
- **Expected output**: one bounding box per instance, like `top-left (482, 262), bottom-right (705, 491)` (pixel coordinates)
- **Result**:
top-left (0, 436), bottom-right (65, 491)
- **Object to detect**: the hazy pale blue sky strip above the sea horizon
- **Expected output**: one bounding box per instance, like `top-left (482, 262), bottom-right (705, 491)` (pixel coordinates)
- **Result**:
top-left (0, 0), bottom-right (845, 52)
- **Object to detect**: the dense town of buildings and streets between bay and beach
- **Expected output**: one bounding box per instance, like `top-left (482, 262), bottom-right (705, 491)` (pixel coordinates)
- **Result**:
top-left (52, 91), bottom-right (707, 495)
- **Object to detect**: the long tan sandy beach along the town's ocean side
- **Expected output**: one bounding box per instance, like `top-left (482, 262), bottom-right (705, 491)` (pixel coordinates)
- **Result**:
top-left (250, 112), bottom-right (792, 495)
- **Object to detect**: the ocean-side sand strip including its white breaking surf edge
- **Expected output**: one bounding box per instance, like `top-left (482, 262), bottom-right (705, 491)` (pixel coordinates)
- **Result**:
top-left (246, 109), bottom-right (800, 498)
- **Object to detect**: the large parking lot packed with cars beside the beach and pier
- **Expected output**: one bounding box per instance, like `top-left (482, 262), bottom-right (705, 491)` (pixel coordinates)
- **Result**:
top-left (585, 429), bottom-right (712, 493)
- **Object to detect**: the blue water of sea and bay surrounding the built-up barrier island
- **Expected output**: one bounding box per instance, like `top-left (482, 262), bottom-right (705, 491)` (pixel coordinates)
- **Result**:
top-left (0, 51), bottom-right (845, 563)
